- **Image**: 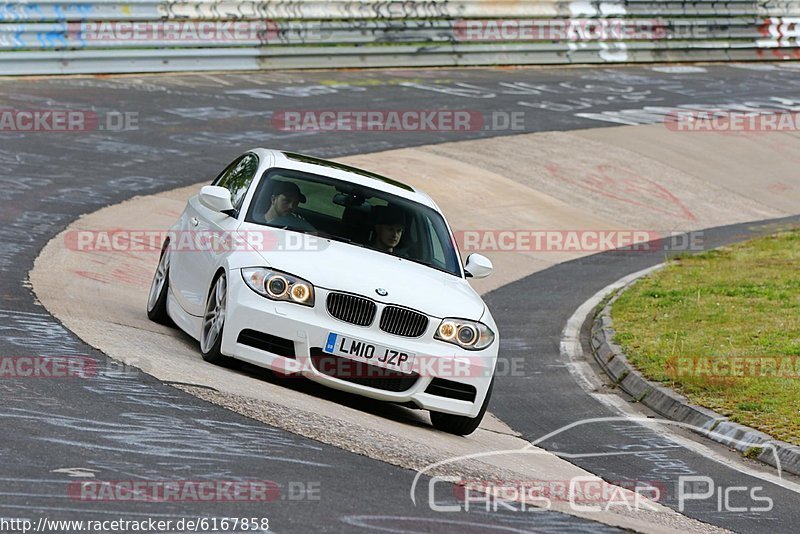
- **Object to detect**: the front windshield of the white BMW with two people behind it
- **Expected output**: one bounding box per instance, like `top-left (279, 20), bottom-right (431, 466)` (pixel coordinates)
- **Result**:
top-left (245, 169), bottom-right (461, 277)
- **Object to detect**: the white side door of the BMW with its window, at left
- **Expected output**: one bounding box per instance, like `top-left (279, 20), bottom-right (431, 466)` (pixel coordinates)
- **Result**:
top-left (170, 153), bottom-right (259, 316)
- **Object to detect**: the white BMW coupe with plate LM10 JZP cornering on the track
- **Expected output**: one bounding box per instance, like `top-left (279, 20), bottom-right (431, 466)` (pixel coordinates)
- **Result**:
top-left (147, 148), bottom-right (499, 435)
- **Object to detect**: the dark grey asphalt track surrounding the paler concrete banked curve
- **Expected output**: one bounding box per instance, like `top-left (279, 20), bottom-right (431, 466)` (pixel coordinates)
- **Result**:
top-left (0, 66), bottom-right (800, 532)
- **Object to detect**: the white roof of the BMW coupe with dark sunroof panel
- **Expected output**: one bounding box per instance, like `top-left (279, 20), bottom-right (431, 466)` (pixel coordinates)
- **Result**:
top-left (250, 148), bottom-right (441, 211)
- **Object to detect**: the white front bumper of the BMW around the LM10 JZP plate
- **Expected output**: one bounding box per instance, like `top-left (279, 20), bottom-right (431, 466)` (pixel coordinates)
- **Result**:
top-left (222, 270), bottom-right (499, 417)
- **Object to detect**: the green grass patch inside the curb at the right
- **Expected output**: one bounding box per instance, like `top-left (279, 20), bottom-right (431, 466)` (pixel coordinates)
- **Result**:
top-left (612, 230), bottom-right (800, 445)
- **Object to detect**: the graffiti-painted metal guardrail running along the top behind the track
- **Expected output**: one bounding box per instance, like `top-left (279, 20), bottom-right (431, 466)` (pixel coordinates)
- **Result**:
top-left (0, 0), bottom-right (800, 75)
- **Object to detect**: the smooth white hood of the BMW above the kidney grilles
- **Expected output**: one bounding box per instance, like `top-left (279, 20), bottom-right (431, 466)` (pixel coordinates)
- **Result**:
top-left (247, 231), bottom-right (485, 320)
